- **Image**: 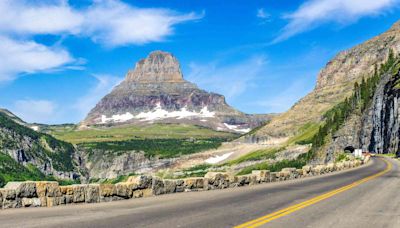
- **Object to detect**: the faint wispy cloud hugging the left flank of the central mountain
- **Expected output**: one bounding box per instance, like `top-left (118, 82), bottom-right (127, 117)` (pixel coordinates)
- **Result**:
top-left (73, 74), bottom-right (123, 119)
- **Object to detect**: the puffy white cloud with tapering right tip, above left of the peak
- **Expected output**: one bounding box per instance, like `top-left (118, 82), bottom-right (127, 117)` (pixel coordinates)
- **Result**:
top-left (83, 0), bottom-right (202, 46)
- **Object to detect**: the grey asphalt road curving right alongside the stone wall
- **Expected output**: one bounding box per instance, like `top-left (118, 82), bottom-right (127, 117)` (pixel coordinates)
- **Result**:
top-left (0, 159), bottom-right (400, 228)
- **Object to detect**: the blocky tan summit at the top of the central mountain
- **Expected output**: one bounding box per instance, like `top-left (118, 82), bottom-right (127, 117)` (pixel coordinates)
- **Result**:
top-left (126, 51), bottom-right (184, 83)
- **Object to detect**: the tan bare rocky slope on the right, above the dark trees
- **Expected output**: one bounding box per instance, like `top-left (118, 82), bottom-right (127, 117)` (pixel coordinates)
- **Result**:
top-left (248, 22), bottom-right (400, 144)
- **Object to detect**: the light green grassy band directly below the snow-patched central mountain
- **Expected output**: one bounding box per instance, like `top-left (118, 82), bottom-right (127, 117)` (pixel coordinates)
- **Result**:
top-left (49, 124), bottom-right (235, 144)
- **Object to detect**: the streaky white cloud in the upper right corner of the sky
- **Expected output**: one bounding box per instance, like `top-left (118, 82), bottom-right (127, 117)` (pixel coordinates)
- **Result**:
top-left (274, 0), bottom-right (399, 43)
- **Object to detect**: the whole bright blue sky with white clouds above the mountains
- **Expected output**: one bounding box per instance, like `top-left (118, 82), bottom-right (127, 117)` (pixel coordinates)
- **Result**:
top-left (0, 0), bottom-right (400, 124)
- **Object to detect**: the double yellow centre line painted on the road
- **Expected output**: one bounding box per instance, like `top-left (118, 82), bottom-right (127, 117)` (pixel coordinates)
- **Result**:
top-left (235, 159), bottom-right (392, 228)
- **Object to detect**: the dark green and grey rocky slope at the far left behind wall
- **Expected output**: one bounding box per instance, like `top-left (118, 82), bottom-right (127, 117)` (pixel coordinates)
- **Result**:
top-left (0, 110), bottom-right (81, 183)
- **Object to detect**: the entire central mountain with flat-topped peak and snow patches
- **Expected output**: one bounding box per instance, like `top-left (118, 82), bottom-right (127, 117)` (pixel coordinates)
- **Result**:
top-left (80, 51), bottom-right (269, 133)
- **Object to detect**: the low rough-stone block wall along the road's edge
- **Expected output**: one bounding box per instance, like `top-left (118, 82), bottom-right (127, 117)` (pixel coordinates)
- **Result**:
top-left (0, 157), bottom-right (369, 209)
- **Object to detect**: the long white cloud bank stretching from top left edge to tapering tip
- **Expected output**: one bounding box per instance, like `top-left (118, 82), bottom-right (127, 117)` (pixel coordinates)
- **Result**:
top-left (0, 0), bottom-right (203, 46)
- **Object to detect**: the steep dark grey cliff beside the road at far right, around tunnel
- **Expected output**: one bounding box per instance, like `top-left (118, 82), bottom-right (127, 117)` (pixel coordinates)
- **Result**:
top-left (326, 60), bottom-right (400, 161)
